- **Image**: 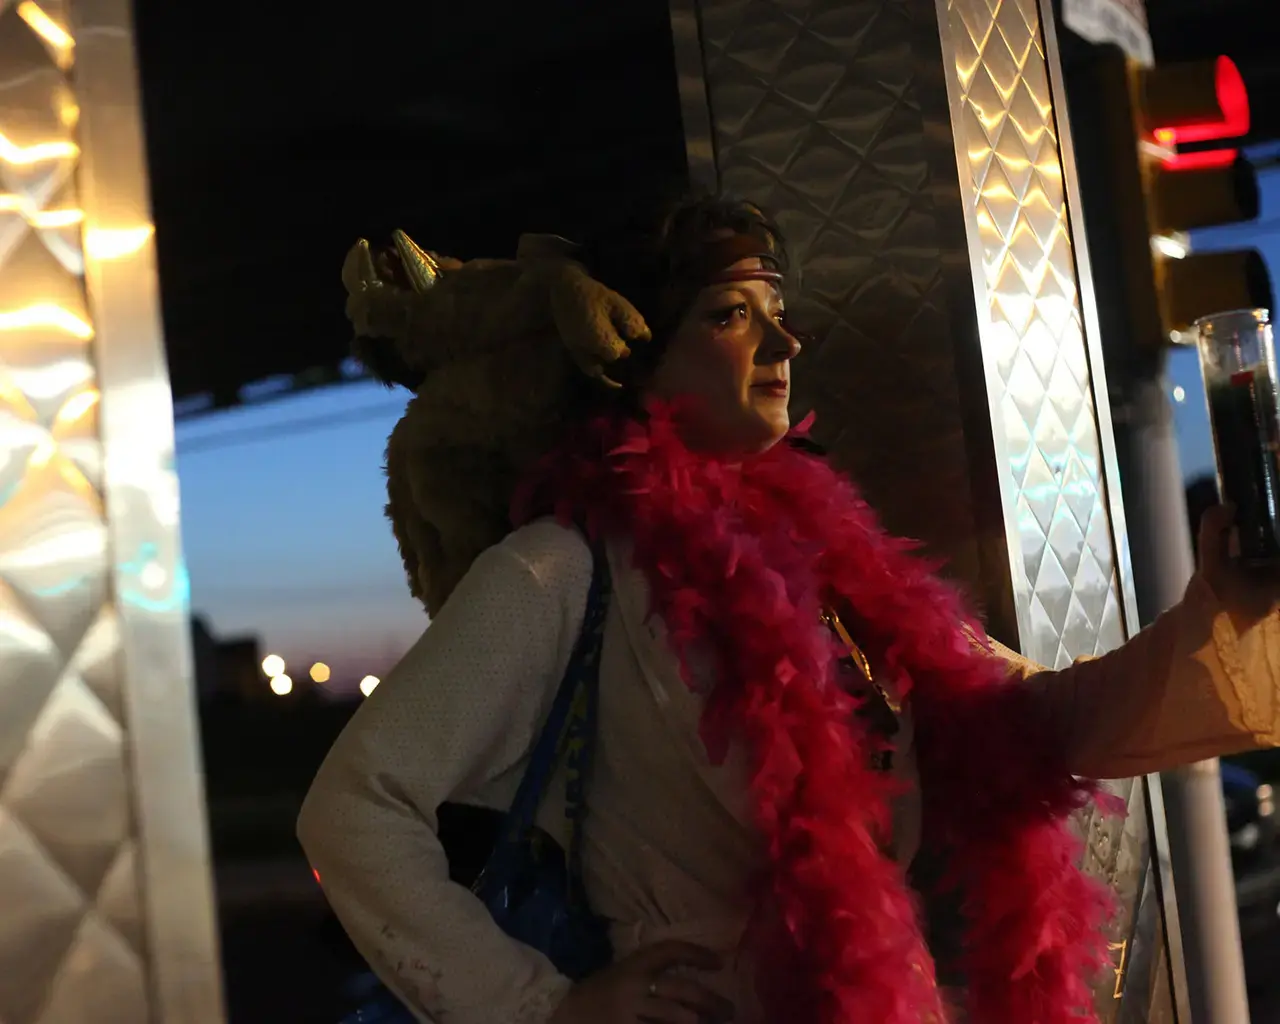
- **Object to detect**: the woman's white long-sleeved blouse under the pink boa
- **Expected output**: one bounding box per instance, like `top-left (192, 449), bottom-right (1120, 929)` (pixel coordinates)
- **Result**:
top-left (298, 521), bottom-right (1280, 1024)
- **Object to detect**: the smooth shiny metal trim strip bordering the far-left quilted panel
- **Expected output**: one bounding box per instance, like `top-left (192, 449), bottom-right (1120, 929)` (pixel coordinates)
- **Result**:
top-left (72, 0), bottom-right (223, 1024)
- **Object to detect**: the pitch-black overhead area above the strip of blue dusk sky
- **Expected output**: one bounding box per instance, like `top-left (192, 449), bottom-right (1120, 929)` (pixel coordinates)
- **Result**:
top-left (137, 0), bottom-right (684, 407)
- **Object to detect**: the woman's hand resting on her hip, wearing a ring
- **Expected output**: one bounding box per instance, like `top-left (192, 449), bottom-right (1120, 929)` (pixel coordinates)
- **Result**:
top-left (548, 942), bottom-right (733, 1024)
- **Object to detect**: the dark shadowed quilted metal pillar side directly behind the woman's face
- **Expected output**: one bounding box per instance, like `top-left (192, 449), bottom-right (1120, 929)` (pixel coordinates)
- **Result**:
top-left (682, 0), bottom-right (1002, 599)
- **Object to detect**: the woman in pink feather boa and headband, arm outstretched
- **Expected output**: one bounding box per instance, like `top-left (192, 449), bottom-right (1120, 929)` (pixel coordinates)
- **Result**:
top-left (300, 200), bottom-right (1280, 1024)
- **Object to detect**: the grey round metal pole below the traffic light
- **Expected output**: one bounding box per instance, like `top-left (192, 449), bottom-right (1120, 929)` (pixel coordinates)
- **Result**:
top-left (1116, 376), bottom-right (1249, 1024)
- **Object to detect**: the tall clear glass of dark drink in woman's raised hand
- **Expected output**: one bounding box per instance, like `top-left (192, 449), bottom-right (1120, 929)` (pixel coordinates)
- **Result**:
top-left (1197, 310), bottom-right (1280, 564)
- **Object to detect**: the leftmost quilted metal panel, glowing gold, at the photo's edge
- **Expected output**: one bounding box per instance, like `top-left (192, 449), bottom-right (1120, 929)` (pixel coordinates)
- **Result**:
top-left (0, 3), bottom-right (148, 1024)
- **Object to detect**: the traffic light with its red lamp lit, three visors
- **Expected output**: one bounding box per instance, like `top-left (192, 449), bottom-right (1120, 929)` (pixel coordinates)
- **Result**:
top-left (1126, 56), bottom-right (1272, 340)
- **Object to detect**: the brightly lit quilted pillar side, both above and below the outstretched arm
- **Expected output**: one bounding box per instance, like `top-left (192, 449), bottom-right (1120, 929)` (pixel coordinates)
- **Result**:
top-left (938, 0), bottom-right (1176, 1024)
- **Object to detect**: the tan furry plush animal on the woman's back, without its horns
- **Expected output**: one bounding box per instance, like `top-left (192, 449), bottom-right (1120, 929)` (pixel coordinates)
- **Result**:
top-left (343, 237), bottom-right (649, 614)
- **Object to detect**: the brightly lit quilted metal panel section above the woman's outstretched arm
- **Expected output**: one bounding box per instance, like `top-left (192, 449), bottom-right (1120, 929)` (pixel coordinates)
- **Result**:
top-left (947, 0), bottom-right (1124, 666)
